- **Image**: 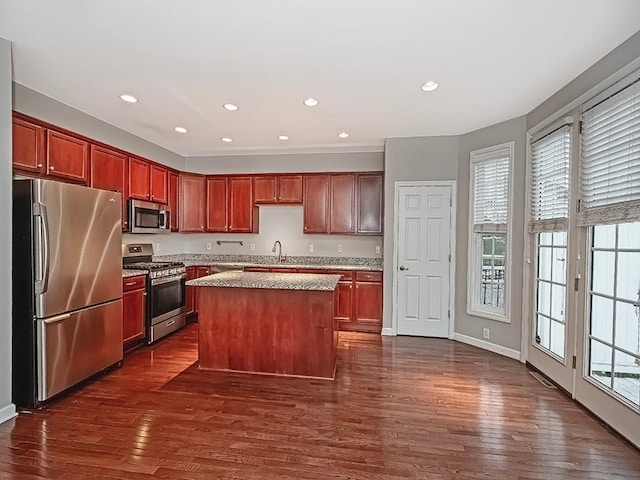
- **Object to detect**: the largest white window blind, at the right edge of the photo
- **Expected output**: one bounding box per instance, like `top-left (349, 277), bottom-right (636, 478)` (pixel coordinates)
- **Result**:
top-left (578, 82), bottom-right (640, 226)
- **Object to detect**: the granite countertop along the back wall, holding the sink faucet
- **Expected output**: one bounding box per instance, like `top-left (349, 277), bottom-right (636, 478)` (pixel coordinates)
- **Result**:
top-left (154, 253), bottom-right (382, 272)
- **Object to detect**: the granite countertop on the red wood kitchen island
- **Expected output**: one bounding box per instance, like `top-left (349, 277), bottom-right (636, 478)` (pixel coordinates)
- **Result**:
top-left (187, 271), bottom-right (340, 291)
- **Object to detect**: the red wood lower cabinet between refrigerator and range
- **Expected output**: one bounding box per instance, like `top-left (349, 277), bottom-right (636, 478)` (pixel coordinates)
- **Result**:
top-left (122, 275), bottom-right (147, 351)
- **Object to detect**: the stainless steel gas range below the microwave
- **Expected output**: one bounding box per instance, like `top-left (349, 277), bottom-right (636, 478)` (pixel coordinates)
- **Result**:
top-left (122, 243), bottom-right (187, 343)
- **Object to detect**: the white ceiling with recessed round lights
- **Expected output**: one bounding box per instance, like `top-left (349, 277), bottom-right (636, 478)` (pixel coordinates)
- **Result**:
top-left (0, 0), bottom-right (640, 156)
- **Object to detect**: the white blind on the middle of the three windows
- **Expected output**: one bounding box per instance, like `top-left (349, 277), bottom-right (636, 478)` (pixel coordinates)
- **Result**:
top-left (529, 125), bottom-right (571, 233)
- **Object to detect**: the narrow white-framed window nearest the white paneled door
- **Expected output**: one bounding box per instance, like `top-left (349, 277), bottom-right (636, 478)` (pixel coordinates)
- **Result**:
top-left (467, 142), bottom-right (514, 322)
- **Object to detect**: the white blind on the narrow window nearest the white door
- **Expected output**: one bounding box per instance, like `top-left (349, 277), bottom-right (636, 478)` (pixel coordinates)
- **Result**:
top-left (471, 147), bottom-right (511, 233)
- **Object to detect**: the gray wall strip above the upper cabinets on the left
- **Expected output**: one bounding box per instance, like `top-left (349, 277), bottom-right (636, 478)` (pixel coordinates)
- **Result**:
top-left (13, 83), bottom-right (184, 170)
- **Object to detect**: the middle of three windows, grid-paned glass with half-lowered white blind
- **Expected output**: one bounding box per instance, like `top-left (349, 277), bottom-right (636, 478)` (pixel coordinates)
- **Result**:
top-left (529, 125), bottom-right (571, 359)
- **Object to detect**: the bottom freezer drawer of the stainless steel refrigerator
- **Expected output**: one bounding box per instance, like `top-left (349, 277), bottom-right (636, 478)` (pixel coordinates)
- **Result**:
top-left (36, 299), bottom-right (122, 402)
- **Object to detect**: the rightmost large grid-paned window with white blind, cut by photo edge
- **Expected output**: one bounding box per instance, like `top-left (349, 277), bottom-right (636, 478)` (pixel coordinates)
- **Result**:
top-left (578, 78), bottom-right (640, 404)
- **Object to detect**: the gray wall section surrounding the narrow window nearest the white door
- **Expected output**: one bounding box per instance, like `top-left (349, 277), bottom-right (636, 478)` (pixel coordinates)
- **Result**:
top-left (455, 116), bottom-right (526, 351)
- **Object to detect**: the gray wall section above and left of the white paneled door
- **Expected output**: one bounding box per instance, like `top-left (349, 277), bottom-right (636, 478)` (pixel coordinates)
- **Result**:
top-left (382, 136), bottom-right (458, 328)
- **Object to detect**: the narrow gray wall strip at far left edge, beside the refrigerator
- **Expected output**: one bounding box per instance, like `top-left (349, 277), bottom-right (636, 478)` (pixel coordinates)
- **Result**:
top-left (0, 38), bottom-right (15, 423)
